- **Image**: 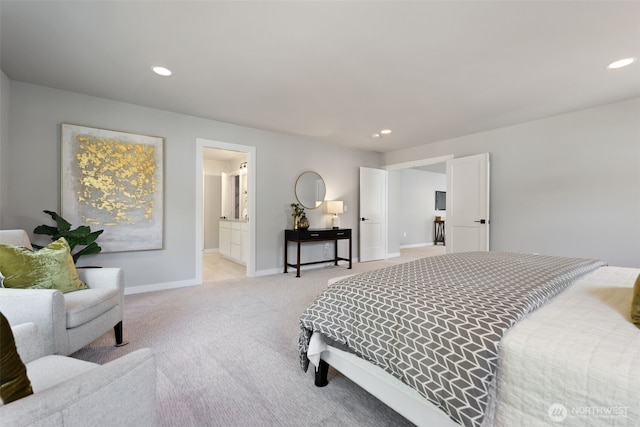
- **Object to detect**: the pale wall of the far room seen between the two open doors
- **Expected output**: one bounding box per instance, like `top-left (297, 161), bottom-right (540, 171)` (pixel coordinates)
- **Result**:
top-left (387, 169), bottom-right (447, 254)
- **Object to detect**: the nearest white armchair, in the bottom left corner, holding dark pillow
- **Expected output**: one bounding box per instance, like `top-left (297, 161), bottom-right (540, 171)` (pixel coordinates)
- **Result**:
top-left (0, 323), bottom-right (157, 427)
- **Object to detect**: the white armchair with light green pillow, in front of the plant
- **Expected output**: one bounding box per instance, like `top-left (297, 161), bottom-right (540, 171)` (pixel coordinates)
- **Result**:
top-left (0, 230), bottom-right (127, 356)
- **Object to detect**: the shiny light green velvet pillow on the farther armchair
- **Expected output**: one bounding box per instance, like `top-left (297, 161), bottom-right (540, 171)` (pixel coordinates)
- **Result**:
top-left (0, 237), bottom-right (87, 292)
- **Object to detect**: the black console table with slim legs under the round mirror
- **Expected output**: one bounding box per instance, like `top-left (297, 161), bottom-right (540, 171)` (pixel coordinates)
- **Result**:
top-left (284, 228), bottom-right (351, 277)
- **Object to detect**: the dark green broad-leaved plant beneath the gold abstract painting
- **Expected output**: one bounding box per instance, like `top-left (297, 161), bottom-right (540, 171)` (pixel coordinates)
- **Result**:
top-left (33, 211), bottom-right (104, 264)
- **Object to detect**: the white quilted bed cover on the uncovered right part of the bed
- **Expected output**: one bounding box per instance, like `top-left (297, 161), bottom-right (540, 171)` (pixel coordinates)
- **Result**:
top-left (487, 267), bottom-right (640, 427)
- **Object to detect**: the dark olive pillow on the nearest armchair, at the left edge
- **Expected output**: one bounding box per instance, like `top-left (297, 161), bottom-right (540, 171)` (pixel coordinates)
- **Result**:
top-left (0, 313), bottom-right (33, 404)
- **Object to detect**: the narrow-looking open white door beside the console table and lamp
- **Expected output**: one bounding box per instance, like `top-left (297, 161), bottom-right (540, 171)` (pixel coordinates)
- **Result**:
top-left (359, 167), bottom-right (387, 262)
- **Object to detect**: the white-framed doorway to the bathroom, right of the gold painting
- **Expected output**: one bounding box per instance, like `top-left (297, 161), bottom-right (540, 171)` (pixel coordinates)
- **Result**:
top-left (195, 138), bottom-right (256, 282)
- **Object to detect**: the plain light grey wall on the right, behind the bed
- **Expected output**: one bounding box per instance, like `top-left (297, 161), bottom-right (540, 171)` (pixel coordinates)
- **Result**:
top-left (385, 98), bottom-right (640, 267)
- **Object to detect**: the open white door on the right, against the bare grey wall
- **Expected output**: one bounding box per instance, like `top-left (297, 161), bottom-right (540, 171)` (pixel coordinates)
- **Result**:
top-left (445, 153), bottom-right (489, 253)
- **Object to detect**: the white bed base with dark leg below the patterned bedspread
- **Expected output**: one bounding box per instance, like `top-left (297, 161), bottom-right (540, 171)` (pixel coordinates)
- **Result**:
top-left (315, 345), bottom-right (460, 427)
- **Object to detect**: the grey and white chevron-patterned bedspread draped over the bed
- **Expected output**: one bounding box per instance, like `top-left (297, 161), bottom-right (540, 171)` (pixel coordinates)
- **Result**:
top-left (299, 252), bottom-right (605, 426)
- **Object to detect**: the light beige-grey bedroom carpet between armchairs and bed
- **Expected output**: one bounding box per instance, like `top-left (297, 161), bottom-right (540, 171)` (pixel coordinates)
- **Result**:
top-left (73, 247), bottom-right (441, 427)
